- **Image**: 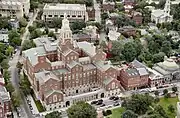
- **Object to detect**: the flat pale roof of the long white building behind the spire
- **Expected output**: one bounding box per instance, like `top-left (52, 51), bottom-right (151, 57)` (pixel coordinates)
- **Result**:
top-left (44, 4), bottom-right (86, 11)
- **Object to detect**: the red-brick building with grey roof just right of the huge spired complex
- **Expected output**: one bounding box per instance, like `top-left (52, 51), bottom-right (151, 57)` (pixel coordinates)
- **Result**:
top-left (119, 60), bottom-right (149, 90)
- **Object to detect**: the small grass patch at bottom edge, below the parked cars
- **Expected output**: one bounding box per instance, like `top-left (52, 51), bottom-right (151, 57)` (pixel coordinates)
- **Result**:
top-left (106, 107), bottom-right (125, 118)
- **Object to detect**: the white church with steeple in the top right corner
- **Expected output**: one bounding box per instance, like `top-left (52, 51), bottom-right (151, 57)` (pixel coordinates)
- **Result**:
top-left (151, 0), bottom-right (173, 24)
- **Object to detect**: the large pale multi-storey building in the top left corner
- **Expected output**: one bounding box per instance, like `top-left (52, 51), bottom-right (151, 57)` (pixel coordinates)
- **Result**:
top-left (0, 0), bottom-right (30, 18)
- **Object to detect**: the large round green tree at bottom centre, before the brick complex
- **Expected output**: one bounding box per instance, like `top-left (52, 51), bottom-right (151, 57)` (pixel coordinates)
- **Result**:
top-left (67, 101), bottom-right (97, 118)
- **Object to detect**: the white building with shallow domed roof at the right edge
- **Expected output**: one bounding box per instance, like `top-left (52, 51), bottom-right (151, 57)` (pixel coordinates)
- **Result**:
top-left (153, 57), bottom-right (180, 82)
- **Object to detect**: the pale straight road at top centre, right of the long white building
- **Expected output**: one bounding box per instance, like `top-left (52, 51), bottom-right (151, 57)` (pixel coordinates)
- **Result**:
top-left (93, 0), bottom-right (101, 23)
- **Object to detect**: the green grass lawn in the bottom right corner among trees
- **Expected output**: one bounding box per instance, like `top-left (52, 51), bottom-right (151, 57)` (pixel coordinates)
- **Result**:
top-left (159, 97), bottom-right (178, 118)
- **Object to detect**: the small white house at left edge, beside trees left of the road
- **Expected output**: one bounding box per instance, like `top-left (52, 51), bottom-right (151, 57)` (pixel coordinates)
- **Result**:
top-left (0, 29), bottom-right (9, 43)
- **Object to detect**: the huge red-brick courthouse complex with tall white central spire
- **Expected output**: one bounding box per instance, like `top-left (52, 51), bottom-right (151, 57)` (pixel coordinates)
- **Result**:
top-left (22, 14), bottom-right (120, 110)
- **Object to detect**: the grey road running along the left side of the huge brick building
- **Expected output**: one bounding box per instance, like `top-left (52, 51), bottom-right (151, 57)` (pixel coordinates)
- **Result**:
top-left (9, 10), bottom-right (38, 118)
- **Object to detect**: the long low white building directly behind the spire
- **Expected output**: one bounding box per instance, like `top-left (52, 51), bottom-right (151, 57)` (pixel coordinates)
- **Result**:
top-left (42, 4), bottom-right (88, 21)
